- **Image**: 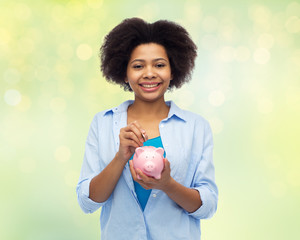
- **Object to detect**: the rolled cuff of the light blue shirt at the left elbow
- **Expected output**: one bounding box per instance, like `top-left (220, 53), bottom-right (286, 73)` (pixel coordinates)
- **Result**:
top-left (77, 178), bottom-right (105, 213)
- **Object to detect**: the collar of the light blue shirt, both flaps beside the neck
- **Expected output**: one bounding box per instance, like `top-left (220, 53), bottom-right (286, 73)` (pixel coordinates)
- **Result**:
top-left (105, 100), bottom-right (187, 122)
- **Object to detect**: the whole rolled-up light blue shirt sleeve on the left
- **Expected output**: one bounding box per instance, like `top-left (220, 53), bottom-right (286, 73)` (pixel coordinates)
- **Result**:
top-left (76, 116), bottom-right (105, 213)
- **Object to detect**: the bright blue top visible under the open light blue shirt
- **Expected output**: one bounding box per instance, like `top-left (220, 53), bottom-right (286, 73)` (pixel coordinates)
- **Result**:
top-left (130, 136), bottom-right (166, 211)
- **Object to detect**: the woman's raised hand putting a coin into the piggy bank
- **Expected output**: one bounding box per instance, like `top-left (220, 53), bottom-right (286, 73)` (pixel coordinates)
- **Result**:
top-left (117, 121), bottom-right (148, 162)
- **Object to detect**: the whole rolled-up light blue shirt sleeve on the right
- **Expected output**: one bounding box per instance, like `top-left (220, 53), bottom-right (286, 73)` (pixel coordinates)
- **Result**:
top-left (189, 122), bottom-right (218, 219)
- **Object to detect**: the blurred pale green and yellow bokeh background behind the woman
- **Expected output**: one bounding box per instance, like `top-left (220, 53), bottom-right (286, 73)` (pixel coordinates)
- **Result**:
top-left (0, 0), bottom-right (300, 240)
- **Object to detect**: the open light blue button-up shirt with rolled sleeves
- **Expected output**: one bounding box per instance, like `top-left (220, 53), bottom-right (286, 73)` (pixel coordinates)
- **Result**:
top-left (76, 100), bottom-right (218, 240)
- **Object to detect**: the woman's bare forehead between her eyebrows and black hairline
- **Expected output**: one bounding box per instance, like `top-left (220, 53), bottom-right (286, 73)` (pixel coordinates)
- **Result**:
top-left (130, 43), bottom-right (168, 60)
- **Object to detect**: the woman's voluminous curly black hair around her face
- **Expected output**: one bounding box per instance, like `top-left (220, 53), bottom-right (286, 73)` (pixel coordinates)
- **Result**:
top-left (100, 18), bottom-right (197, 91)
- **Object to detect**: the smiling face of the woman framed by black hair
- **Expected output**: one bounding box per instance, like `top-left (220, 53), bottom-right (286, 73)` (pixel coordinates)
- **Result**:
top-left (125, 43), bottom-right (172, 102)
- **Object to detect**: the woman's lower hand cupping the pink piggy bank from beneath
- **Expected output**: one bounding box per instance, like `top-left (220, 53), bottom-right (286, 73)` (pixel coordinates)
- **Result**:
top-left (129, 158), bottom-right (173, 191)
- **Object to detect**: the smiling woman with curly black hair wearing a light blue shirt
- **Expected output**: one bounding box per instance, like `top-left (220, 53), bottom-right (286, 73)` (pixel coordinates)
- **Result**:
top-left (76, 18), bottom-right (218, 240)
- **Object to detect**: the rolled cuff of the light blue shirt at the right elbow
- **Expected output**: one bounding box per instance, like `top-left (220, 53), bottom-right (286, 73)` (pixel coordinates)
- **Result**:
top-left (188, 187), bottom-right (217, 219)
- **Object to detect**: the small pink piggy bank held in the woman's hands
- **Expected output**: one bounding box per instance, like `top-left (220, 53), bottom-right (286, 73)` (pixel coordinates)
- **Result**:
top-left (133, 146), bottom-right (164, 179)
